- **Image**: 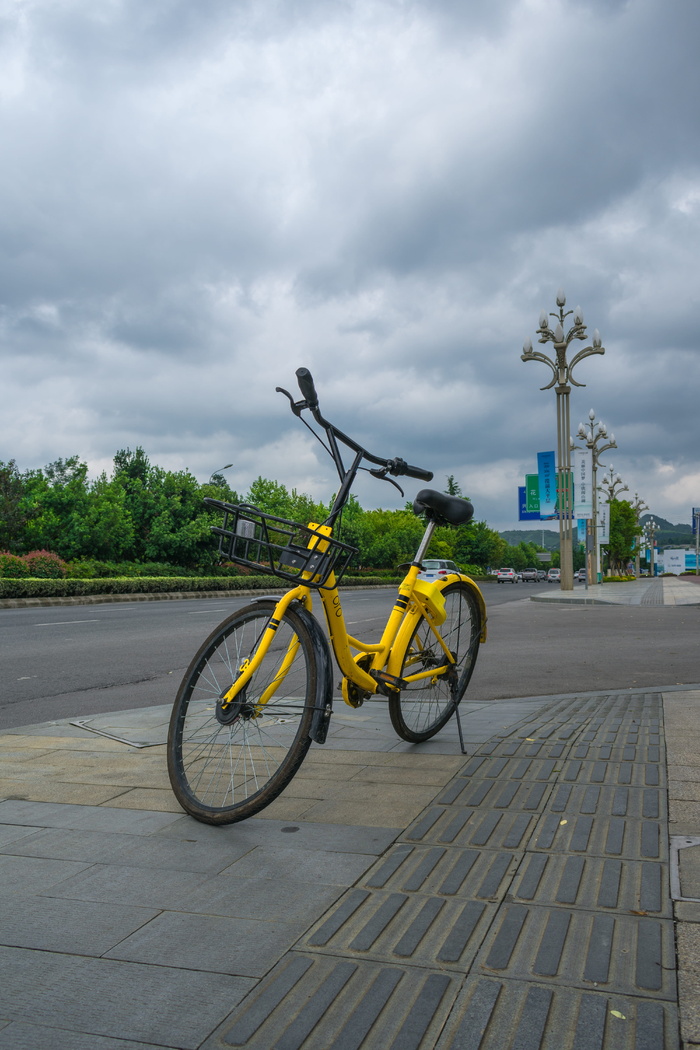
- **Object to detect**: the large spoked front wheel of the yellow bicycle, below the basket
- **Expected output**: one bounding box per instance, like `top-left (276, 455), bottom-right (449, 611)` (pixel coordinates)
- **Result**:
top-left (168, 602), bottom-right (318, 824)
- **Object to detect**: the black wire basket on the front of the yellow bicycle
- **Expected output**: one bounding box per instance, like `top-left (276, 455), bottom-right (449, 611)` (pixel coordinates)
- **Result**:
top-left (205, 497), bottom-right (358, 589)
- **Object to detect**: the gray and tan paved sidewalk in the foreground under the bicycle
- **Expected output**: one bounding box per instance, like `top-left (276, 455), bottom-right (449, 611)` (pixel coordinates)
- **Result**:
top-left (0, 604), bottom-right (700, 1050)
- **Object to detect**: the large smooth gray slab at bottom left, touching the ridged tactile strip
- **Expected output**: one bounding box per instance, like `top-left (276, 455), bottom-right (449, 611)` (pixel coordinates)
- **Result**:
top-left (0, 947), bottom-right (255, 1050)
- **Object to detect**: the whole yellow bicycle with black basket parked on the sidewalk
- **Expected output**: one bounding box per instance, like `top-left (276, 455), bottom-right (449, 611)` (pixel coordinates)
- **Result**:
top-left (168, 369), bottom-right (486, 824)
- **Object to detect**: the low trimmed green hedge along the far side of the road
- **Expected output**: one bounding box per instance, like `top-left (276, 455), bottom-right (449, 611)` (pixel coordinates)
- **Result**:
top-left (0, 576), bottom-right (386, 599)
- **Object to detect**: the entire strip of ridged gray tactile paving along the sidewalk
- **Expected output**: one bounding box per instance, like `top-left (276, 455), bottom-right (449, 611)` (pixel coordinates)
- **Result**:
top-left (203, 693), bottom-right (679, 1050)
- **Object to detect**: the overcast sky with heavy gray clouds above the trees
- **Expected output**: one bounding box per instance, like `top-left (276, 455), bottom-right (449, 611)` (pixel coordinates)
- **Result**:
top-left (0, 0), bottom-right (700, 529)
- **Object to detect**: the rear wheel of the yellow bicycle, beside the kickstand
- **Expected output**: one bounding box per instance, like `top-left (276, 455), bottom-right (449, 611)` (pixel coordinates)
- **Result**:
top-left (388, 582), bottom-right (482, 743)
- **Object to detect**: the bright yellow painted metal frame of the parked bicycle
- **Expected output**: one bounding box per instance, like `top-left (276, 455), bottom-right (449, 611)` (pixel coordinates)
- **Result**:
top-left (221, 522), bottom-right (486, 709)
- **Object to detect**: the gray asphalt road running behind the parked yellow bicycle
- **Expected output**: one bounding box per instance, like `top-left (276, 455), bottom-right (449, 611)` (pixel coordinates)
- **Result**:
top-left (0, 583), bottom-right (700, 730)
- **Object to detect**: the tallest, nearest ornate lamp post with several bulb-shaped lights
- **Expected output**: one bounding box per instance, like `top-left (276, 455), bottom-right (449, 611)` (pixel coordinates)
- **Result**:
top-left (521, 289), bottom-right (606, 590)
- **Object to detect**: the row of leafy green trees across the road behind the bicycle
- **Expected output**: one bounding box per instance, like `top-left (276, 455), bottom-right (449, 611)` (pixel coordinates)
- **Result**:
top-left (0, 446), bottom-right (543, 572)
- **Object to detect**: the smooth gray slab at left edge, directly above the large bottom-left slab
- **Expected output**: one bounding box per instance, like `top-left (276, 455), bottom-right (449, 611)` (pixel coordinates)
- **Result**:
top-left (0, 897), bottom-right (158, 956)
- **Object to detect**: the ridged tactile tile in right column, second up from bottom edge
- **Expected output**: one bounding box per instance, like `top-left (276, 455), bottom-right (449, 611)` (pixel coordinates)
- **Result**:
top-left (475, 904), bottom-right (676, 1002)
